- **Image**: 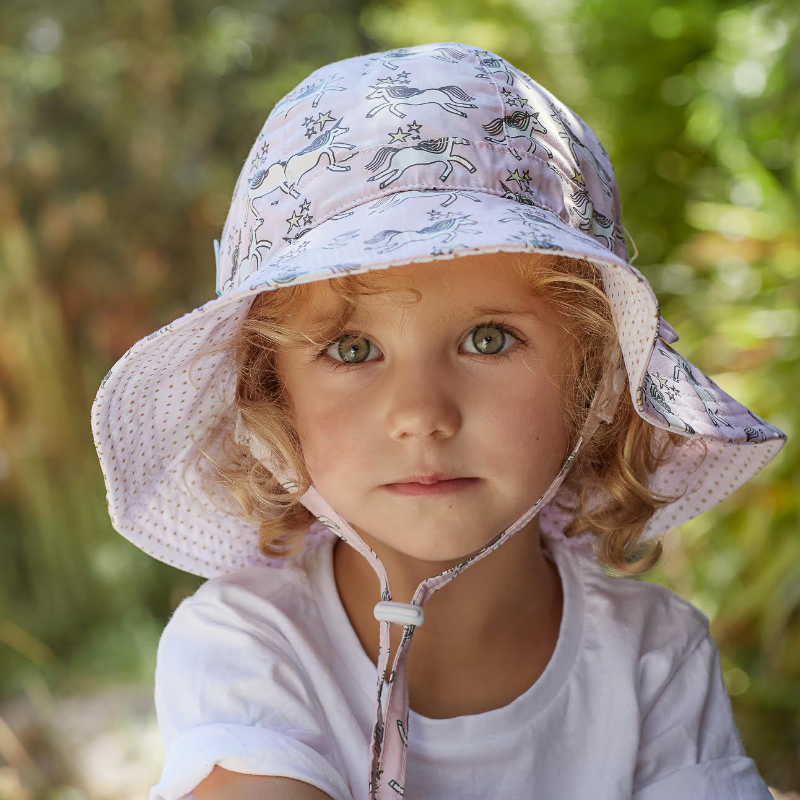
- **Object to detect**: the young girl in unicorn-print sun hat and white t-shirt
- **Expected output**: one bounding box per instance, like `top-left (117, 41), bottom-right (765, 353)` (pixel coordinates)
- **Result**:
top-left (92, 42), bottom-right (785, 800)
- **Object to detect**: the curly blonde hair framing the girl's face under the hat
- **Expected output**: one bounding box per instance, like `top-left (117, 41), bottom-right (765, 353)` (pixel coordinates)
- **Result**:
top-left (189, 253), bottom-right (688, 576)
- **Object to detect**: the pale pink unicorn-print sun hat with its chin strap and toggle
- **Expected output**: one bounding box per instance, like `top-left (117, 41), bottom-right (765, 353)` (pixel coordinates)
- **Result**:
top-left (92, 42), bottom-right (786, 799)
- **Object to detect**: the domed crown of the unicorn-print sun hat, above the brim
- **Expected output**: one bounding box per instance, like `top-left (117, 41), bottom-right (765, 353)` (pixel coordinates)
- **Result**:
top-left (216, 42), bottom-right (627, 294)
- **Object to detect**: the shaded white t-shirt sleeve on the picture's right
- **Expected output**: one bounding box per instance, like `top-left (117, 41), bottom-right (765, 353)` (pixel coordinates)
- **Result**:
top-left (632, 628), bottom-right (772, 800)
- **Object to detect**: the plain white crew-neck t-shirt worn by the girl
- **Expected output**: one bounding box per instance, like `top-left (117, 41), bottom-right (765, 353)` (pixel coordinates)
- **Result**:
top-left (150, 529), bottom-right (771, 800)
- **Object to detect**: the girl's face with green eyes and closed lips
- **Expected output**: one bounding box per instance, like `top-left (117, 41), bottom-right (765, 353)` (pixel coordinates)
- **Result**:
top-left (277, 253), bottom-right (568, 562)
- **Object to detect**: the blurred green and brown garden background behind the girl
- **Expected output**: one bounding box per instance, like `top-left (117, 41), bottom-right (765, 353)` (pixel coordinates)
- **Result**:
top-left (0, 0), bottom-right (800, 800)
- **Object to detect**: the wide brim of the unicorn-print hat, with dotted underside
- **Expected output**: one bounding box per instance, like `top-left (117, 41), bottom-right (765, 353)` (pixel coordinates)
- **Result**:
top-left (92, 189), bottom-right (786, 578)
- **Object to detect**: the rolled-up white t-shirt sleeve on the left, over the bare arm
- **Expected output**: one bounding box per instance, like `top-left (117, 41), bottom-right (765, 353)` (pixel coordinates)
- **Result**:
top-left (150, 582), bottom-right (352, 800)
